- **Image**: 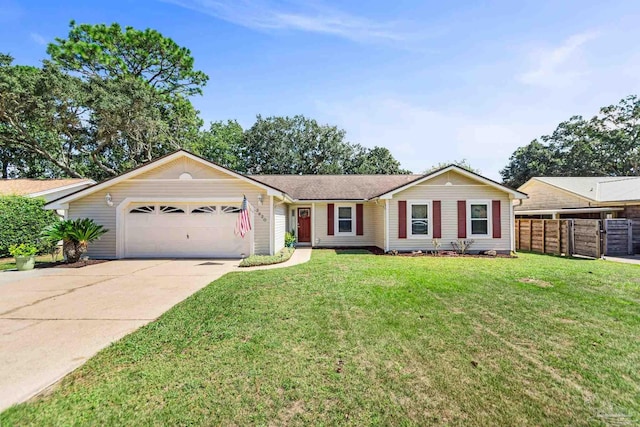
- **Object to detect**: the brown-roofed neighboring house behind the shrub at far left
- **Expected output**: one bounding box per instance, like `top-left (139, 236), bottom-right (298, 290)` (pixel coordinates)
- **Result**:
top-left (0, 178), bottom-right (96, 215)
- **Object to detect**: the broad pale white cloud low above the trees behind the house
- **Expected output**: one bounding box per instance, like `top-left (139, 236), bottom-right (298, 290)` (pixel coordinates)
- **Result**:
top-left (316, 98), bottom-right (548, 180)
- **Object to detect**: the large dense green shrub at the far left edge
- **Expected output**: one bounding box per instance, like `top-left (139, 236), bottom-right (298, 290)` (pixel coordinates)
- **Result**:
top-left (0, 196), bottom-right (59, 256)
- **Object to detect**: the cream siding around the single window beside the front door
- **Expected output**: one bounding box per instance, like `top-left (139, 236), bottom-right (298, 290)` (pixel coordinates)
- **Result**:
top-left (313, 202), bottom-right (384, 247)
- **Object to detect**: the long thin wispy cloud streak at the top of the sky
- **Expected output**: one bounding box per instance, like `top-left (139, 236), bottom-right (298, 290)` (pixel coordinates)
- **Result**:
top-left (163, 0), bottom-right (412, 42)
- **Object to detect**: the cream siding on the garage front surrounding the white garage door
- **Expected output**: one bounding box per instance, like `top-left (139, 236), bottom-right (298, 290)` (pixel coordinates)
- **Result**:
top-left (68, 162), bottom-right (272, 258)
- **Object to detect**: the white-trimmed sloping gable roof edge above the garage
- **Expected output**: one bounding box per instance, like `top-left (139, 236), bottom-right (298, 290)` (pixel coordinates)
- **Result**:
top-left (45, 150), bottom-right (285, 209)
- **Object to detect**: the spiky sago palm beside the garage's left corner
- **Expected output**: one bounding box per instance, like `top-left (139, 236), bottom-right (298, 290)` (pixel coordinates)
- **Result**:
top-left (43, 218), bottom-right (109, 263)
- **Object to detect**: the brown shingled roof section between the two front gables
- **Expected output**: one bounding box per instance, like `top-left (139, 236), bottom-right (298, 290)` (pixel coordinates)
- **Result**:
top-left (250, 175), bottom-right (424, 200)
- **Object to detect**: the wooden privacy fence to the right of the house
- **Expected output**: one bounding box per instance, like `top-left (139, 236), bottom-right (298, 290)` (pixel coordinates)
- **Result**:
top-left (515, 219), bottom-right (640, 258)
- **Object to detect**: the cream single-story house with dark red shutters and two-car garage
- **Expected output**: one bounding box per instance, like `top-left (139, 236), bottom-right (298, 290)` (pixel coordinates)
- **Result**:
top-left (47, 150), bottom-right (527, 258)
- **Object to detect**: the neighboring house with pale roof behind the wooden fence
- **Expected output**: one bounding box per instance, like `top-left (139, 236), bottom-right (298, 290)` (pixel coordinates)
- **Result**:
top-left (515, 176), bottom-right (640, 219)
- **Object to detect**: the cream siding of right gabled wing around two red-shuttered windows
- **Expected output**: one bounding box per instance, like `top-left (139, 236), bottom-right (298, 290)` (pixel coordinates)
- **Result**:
top-left (389, 172), bottom-right (511, 252)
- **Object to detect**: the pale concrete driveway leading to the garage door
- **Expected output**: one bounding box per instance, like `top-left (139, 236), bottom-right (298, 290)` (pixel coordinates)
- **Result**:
top-left (0, 260), bottom-right (238, 411)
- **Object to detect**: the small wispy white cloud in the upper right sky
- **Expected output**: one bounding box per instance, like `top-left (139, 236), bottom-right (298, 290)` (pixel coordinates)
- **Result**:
top-left (519, 32), bottom-right (600, 87)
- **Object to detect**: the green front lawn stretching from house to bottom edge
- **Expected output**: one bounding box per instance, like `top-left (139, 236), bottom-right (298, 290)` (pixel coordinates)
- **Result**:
top-left (0, 250), bottom-right (640, 426)
